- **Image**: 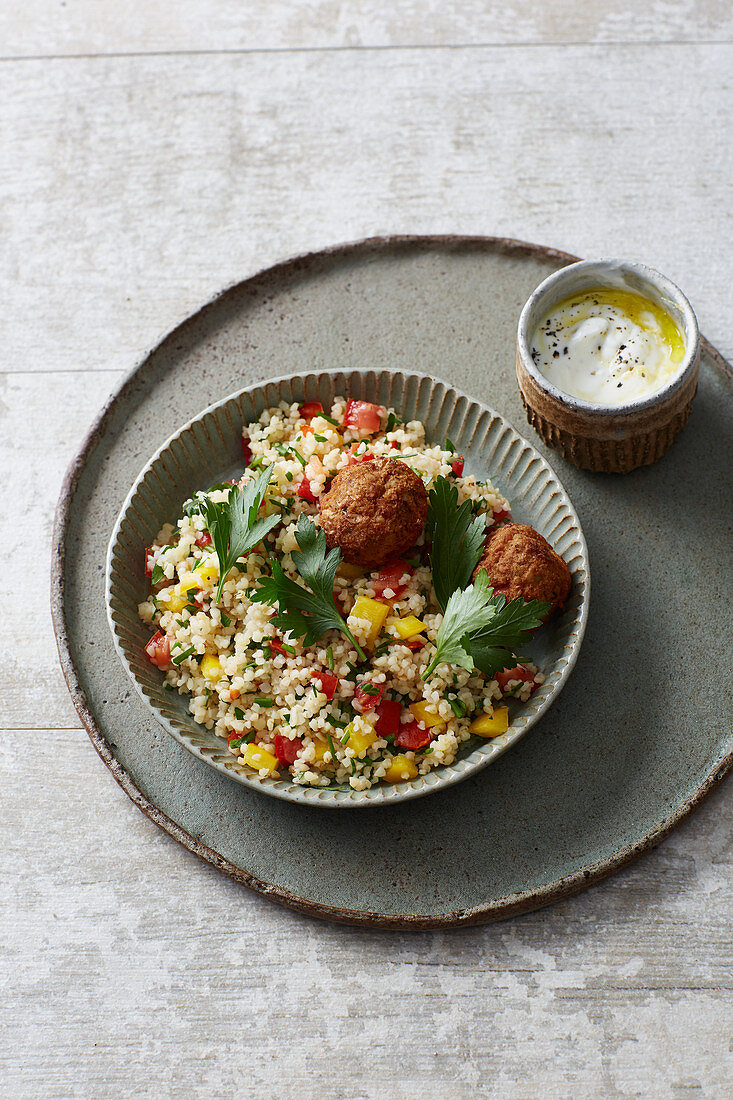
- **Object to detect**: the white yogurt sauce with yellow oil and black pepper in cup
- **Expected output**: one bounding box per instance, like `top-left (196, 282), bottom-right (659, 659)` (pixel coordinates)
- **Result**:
top-left (530, 287), bottom-right (685, 405)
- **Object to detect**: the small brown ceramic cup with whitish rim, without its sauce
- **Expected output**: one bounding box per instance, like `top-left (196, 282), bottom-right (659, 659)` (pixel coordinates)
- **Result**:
top-left (516, 260), bottom-right (700, 473)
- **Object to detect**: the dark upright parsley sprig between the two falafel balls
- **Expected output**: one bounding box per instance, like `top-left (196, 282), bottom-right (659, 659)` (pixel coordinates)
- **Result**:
top-left (426, 477), bottom-right (486, 612)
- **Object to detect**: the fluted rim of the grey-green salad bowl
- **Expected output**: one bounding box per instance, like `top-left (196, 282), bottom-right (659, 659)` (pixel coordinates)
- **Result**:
top-left (105, 367), bottom-right (591, 810)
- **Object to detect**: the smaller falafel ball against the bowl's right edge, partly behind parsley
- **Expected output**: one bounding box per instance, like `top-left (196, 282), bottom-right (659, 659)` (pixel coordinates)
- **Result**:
top-left (473, 524), bottom-right (571, 616)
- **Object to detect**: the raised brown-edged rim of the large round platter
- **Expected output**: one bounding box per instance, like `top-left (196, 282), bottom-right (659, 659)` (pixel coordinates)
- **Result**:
top-left (51, 234), bottom-right (733, 931)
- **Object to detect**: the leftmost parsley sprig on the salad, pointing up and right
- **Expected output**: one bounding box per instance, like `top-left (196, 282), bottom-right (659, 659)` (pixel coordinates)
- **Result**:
top-left (197, 466), bottom-right (281, 604)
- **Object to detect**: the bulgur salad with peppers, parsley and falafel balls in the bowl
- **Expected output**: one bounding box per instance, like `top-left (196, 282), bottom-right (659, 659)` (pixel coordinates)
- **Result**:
top-left (139, 397), bottom-right (570, 791)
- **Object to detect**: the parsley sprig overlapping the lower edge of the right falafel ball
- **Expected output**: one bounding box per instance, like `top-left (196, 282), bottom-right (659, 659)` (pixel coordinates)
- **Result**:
top-left (423, 569), bottom-right (550, 680)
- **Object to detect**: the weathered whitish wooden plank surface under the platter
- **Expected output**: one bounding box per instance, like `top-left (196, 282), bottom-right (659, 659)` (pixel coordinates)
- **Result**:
top-left (0, 0), bottom-right (733, 1098)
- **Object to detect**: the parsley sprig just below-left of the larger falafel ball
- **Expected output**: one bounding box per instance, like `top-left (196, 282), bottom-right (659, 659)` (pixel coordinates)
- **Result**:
top-left (250, 516), bottom-right (367, 661)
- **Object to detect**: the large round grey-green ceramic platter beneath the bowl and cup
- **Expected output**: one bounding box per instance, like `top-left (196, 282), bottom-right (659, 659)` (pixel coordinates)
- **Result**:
top-left (52, 238), bottom-right (733, 928)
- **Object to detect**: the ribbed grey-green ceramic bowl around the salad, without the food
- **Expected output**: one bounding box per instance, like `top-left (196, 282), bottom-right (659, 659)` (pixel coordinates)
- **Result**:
top-left (107, 371), bottom-right (590, 809)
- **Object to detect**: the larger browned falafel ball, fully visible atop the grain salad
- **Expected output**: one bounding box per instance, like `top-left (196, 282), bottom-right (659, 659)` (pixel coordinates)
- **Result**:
top-left (320, 458), bottom-right (428, 569)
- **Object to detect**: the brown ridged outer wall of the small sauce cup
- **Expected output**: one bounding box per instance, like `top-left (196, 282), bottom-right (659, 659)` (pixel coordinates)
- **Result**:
top-left (516, 348), bottom-right (700, 474)
